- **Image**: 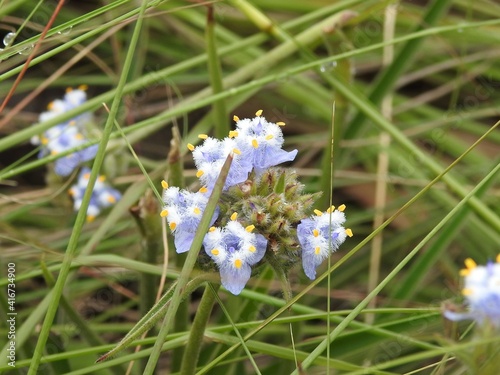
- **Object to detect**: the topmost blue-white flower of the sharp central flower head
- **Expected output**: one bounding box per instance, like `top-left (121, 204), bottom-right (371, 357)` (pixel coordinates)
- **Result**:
top-left (230, 110), bottom-right (297, 174)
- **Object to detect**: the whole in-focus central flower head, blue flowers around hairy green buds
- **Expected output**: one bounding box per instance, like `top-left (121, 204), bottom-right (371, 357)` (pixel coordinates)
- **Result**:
top-left (161, 111), bottom-right (352, 294)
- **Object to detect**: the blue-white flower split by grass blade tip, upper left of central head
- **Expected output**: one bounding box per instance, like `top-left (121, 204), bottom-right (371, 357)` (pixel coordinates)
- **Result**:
top-left (188, 134), bottom-right (252, 192)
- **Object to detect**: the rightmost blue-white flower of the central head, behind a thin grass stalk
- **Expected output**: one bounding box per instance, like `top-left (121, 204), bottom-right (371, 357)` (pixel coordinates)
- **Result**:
top-left (297, 205), bottom-right (352, 280)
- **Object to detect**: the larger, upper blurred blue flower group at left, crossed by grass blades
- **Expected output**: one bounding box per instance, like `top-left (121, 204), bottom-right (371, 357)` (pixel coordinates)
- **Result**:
top-left (31, 86), bottom-right (97, 176)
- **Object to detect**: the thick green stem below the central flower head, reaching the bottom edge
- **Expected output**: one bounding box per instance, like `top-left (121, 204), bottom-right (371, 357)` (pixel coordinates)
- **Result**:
top-left (181, 284), bottom-right (220, 375)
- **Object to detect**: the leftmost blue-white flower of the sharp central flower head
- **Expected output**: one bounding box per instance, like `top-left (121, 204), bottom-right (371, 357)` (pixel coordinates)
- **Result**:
top-left (160, 181), bottom-right (219, 253)
